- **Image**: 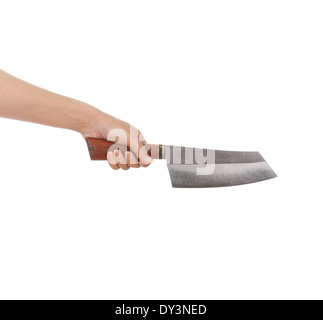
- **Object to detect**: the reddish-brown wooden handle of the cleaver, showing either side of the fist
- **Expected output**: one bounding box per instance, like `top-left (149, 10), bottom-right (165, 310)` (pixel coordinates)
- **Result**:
top-left (85, 138), bottom-right (162, 160)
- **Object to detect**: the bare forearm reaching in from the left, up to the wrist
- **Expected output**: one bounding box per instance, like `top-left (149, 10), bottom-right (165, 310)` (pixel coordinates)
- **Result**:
top-left (0, 70), bottom-right (114, 135)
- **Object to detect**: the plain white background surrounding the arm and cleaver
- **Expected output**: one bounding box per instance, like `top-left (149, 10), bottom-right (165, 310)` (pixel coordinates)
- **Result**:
top-left (0, 0), bottom-right (323, 299)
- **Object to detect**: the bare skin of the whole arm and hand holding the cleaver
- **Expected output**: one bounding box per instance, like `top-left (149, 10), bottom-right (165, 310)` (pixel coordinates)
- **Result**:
top-left (0, 70), bottom-right (152, 170)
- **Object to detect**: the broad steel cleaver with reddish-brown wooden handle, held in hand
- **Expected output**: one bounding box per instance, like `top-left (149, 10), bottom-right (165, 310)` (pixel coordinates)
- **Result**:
top-left (86, 138), bottom-right (277, 188)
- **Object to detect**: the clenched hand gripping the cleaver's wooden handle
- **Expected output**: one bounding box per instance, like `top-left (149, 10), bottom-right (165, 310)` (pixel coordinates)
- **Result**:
top-left (82, 114), bottom-right (152, 170)
